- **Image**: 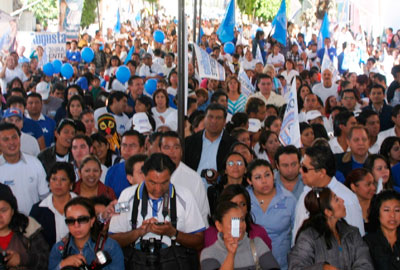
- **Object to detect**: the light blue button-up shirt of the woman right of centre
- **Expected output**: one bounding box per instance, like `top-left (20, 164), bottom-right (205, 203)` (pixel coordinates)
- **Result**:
top-left (247, 185), bottom-right (296, 270)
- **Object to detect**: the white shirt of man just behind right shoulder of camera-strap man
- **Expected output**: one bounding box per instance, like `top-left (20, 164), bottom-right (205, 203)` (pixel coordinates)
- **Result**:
top-left (171, 162), bottom-right (210, 225)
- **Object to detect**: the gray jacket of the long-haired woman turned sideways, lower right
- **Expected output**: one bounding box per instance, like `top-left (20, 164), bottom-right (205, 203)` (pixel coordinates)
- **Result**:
top-left (288, 221), bottom-right (374, 270)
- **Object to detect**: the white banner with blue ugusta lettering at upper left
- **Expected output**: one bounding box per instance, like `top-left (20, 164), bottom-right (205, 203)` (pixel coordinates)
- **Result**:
top-left (17, 31), bottom-right (67, 63)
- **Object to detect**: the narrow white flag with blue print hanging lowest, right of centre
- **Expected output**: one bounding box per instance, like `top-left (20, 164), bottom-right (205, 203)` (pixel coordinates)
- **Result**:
top-left (279, 80), bottom-right (301, 148)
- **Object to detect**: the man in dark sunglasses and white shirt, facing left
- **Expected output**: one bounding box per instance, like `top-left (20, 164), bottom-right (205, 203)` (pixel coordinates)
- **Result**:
top-left (292, 146), bottom-right (365, 244)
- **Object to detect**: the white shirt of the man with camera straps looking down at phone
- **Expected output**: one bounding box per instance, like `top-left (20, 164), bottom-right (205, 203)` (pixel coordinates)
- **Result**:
top-left (110, 182), bottom-right (206, 246)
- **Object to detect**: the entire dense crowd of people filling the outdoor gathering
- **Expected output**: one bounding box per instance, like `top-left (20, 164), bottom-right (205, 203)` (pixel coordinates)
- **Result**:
top-left (0, 12), bottom-right (400, 270)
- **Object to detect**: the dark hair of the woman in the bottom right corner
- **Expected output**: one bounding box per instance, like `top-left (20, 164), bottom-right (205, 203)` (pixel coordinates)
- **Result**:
top-left (368, 190), bottom-right (400, 232)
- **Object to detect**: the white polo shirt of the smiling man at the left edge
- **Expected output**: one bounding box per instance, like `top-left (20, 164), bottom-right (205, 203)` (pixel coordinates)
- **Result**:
top-left (0, 153), bottom-right (49, 215)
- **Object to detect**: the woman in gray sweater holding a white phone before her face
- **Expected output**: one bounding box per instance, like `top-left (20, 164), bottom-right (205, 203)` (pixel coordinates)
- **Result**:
top-left (200, 201), bottom-right (279, 270)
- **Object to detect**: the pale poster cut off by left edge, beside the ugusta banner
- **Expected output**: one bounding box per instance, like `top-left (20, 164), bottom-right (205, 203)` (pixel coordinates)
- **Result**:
top-left (0, 10), bottom-right (18, 56)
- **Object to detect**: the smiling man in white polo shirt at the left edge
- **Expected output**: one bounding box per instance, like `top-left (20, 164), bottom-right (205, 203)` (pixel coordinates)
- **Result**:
top-left (0, 123), bottom-right (49, 215)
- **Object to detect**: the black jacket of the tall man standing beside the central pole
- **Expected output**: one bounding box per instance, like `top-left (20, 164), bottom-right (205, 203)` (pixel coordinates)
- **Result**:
top-left (185, 130), bottom-right (236, 173)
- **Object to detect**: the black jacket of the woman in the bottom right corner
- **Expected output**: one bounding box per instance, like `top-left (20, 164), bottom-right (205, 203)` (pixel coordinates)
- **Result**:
top-left (364, 228), bottom-right (400, 270)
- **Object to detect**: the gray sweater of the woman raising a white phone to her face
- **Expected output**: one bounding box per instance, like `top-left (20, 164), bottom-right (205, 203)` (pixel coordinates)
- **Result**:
top-left (200, 233), bottom-right (279, 270)
